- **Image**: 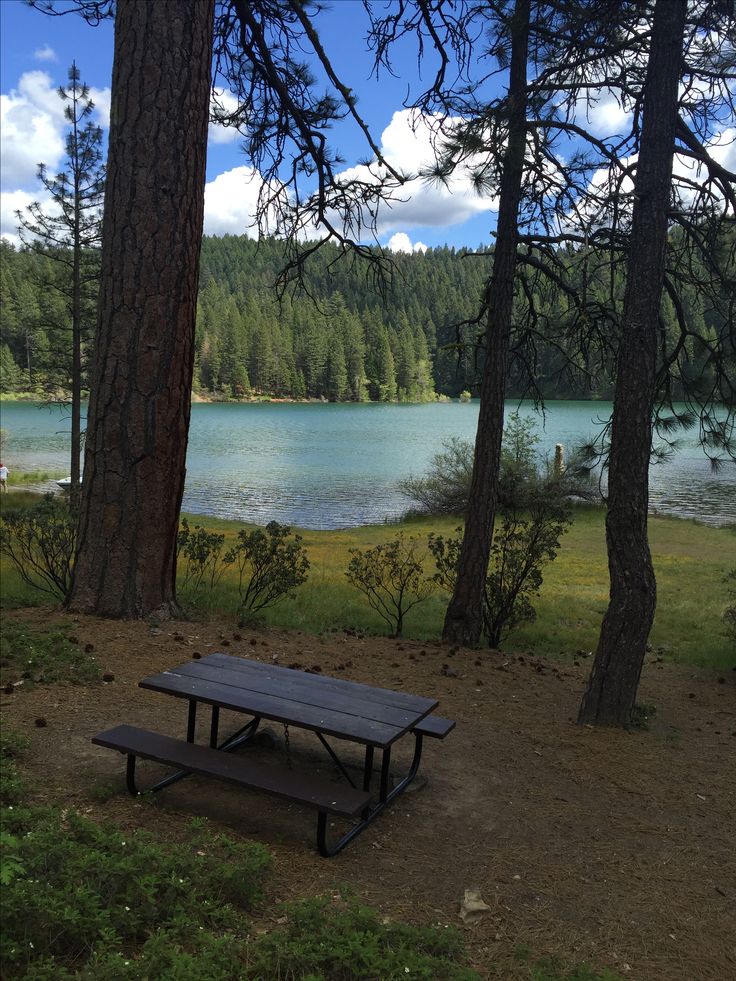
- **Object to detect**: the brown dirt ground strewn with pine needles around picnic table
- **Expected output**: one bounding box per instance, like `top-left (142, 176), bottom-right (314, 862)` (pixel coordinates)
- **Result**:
top-left (1, 610), bottom-right (736, 981)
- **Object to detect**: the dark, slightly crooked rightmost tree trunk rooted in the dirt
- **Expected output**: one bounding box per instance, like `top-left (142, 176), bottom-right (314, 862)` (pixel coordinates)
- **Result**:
top-left (578, 0), bottom-right (686, 725)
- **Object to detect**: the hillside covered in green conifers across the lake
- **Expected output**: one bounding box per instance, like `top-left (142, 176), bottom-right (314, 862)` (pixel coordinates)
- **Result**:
top-left (0, 236), bottom-right (729, 402)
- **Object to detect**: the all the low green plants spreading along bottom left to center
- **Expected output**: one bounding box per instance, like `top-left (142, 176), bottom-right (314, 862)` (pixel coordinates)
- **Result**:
top-left (0, 788), bottom-right (478, 981)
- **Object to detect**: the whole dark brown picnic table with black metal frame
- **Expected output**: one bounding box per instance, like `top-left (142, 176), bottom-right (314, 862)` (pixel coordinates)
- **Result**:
top-left (92, 653), bottom-right (455, 856)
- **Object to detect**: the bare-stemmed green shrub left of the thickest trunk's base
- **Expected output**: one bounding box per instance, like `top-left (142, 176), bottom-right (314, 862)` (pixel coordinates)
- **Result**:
top-left (0, 494), bottom-right (76, 599)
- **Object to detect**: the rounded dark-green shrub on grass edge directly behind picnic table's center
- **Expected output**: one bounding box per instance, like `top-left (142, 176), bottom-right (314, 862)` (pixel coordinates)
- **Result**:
top-left (232, 521), bottom-right (309, 625)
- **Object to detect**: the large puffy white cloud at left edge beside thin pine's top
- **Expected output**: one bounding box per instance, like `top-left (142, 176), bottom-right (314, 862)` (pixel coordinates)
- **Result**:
top-left (0, 71), bottom-right (65, 189)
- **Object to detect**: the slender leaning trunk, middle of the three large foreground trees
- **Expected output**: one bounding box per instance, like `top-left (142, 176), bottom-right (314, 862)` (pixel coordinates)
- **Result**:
top-left (442, 0), bottom-right (530, 646)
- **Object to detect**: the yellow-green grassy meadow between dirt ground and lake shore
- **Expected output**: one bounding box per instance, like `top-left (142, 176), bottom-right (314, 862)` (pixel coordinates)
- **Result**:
top-left (0, 494), bottom-right (736, 668)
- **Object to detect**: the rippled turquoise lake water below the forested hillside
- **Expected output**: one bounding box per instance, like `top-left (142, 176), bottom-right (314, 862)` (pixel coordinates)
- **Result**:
top-left (0, 402), bottom-right (736, 528)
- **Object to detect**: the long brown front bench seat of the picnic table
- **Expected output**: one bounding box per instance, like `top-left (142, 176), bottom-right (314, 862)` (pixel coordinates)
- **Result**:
top-left (92, 725), bottom-right (370, 817)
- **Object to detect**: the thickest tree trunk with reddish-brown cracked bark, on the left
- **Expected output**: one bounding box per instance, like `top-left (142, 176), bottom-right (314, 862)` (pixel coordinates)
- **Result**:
top-left (68, 0), bottom-right (214, 617)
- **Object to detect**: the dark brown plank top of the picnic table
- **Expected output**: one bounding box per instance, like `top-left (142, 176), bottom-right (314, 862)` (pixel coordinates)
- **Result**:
top-left (140, 653), bottom-right (438, 748)
